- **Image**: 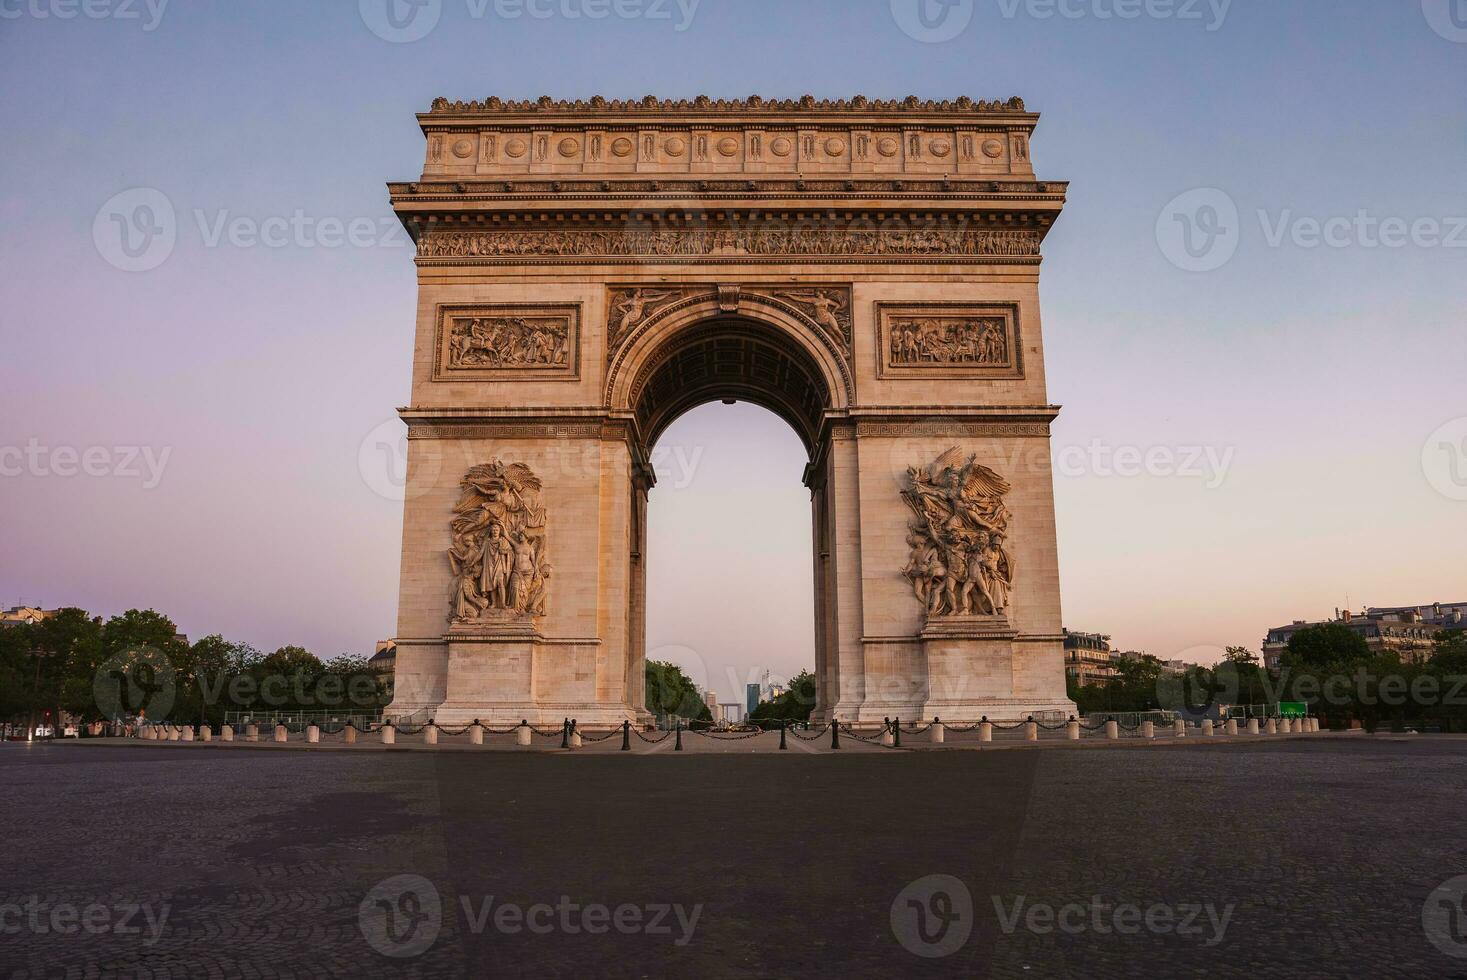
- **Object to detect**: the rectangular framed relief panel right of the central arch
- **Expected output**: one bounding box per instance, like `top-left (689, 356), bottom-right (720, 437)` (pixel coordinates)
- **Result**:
top-left (876, 302), bottom-right (1024, 379)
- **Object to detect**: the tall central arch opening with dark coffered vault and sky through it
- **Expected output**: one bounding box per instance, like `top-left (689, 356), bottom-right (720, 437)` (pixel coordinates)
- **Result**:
top-left (632, 317), bottom-right (830, 720)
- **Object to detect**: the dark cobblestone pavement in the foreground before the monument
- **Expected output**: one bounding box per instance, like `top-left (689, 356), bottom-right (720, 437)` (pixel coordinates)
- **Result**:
top-left (0, 735), bottom-right (1467, 979)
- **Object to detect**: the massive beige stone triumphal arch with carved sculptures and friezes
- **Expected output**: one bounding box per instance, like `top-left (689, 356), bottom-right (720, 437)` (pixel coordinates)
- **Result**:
top-left (389, 97), bottom-right (1072, 726)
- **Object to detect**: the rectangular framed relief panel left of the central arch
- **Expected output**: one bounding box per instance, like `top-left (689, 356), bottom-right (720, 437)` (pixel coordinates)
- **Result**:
top-left (433, 304), bottom-right (581, 381)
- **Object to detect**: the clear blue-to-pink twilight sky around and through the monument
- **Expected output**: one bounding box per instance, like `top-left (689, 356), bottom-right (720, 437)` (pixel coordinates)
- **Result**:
top-left (0, 0), bottom-right (1467, 698)
